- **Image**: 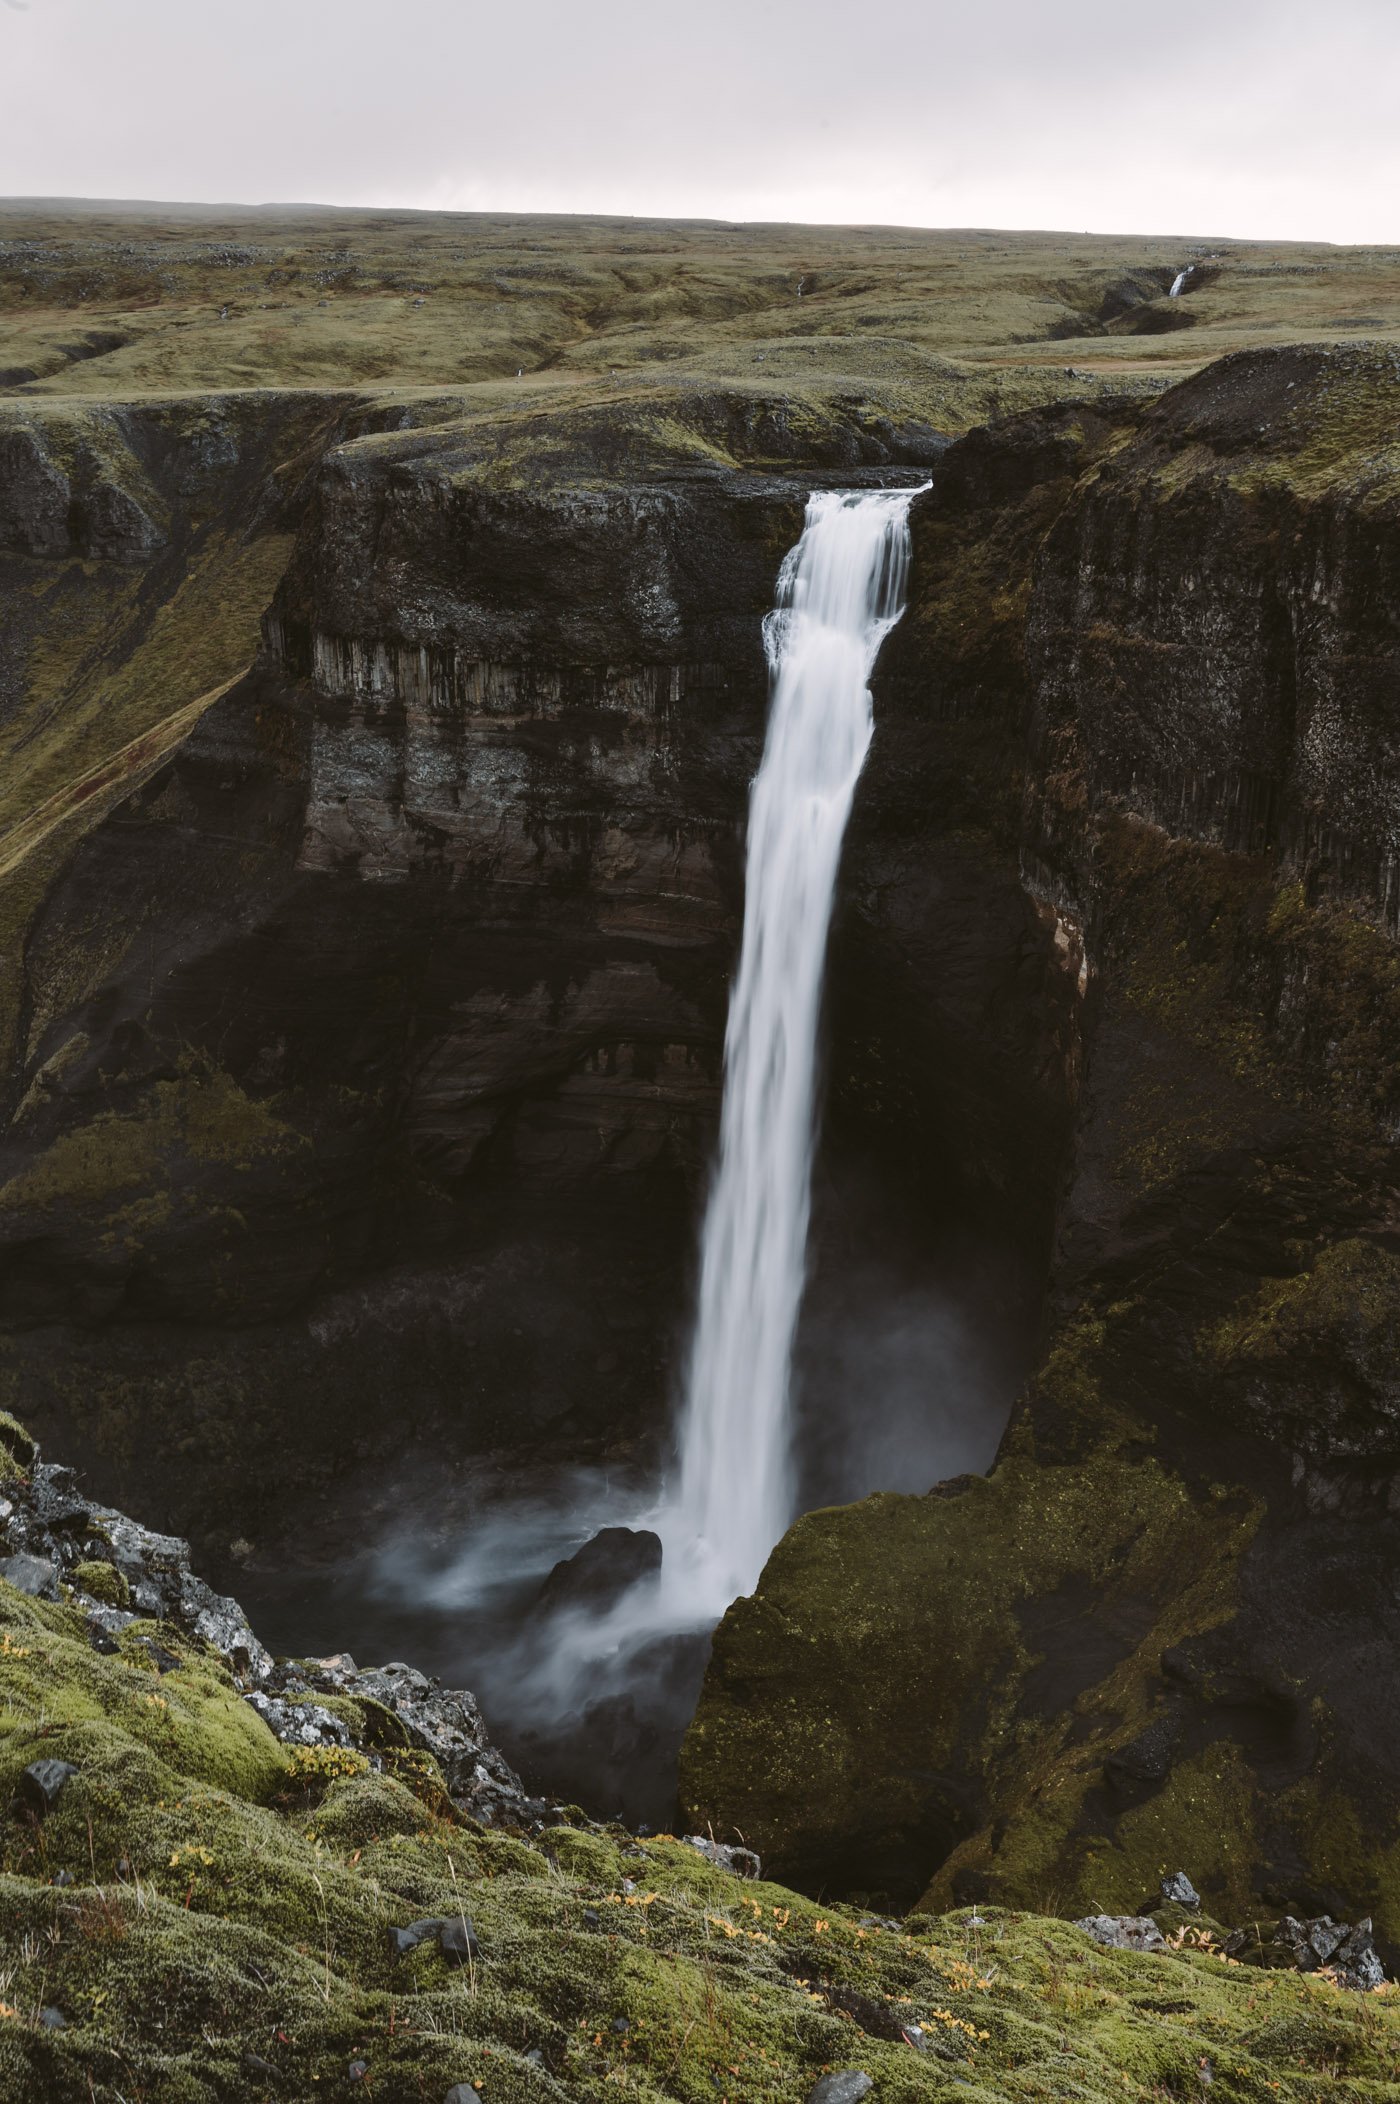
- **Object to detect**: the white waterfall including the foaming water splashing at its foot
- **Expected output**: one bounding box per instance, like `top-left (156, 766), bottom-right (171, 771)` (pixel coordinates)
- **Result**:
top-left (366, 490), bottom-right (918, 1788)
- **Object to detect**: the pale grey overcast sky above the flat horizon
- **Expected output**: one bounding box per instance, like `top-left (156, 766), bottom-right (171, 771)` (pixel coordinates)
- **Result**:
top-left (0, 0), bottom-right (1400, 242)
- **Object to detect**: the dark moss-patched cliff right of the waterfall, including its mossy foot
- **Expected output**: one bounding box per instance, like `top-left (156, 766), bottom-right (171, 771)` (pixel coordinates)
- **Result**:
top-left (682, 349), bottom-right (1400, 1938)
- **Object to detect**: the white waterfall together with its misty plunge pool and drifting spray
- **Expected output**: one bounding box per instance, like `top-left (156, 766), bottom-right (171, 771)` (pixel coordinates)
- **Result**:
top-left (234, 488), bottom-right (1031, 1822)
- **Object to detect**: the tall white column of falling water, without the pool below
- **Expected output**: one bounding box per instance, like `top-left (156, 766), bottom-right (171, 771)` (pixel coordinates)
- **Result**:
top-left (659, 490), bottom-right (916, 1614)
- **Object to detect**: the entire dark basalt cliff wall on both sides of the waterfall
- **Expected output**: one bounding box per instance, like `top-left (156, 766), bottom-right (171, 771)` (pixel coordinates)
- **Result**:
top-left (0, 349), bottom-right (1400, 1936)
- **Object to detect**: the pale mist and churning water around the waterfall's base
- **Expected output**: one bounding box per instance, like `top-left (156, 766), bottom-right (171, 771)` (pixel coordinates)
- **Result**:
top-left (355, 1228), bottom-right (1036, 1828)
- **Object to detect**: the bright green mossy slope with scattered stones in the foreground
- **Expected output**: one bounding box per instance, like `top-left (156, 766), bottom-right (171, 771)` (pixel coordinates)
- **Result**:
top-left (0, 1586), bottom-right (1400, 2104)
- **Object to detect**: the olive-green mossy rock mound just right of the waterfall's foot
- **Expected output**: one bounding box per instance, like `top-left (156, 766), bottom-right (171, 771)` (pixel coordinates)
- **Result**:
top-left (682, 1447), bottom-right (1257, 1910)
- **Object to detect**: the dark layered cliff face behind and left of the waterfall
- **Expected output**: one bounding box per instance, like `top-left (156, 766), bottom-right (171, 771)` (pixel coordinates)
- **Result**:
top-left (0, 402), bottom-right (1063, 1549)
